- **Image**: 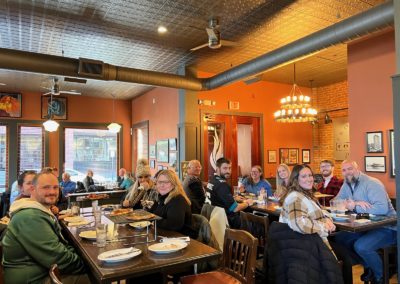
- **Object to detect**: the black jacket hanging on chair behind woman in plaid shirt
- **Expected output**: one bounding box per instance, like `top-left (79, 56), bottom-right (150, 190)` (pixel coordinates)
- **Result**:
top-left (266, 222), bottom-right (343, 284)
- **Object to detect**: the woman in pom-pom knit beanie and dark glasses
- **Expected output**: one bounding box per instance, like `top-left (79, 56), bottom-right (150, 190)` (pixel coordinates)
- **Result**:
top-left (122, 159), bottom-right (157, 209)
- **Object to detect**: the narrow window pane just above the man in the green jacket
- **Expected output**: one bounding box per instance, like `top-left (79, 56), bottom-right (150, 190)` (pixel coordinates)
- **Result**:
top-left (18, 126), bottom-right (44, 172)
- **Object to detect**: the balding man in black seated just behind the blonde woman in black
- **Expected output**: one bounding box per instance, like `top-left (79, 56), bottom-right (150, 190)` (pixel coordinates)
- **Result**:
top-left (183, 160), bottom-right (206, 214)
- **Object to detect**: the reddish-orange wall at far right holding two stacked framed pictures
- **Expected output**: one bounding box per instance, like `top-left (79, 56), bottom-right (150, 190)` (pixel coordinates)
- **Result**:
top-left (348, 32), bottom-right (396, 196)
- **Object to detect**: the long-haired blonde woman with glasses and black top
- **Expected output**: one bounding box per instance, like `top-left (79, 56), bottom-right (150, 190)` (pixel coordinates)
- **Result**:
top-left (150, 170), bottom-right (197, 238)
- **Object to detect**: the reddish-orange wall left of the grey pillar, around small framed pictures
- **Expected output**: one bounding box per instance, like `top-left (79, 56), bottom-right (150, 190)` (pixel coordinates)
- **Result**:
top-left (132, 88), bottom-right (179, 174)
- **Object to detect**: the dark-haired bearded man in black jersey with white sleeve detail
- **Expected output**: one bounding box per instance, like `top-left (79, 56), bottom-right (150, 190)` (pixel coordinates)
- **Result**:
top-left (207, 158), bottom-right (253, 229)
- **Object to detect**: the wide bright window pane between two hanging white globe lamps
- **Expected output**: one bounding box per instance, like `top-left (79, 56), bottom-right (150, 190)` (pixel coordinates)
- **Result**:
top-left (65, 128), bottom-right (118, 182)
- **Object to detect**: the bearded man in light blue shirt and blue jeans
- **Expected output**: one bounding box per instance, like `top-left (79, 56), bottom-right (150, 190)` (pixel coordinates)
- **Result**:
top-left (335, 160), bottom-right (397, 283)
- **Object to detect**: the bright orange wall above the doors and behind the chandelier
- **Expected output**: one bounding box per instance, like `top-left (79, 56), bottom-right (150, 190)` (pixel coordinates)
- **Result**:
top-left (198, 76), bottom-right (313, 177)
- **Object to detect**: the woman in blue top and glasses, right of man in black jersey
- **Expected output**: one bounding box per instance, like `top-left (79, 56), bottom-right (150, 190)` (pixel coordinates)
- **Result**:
top-left (240, 165), bottom-right (272, 196)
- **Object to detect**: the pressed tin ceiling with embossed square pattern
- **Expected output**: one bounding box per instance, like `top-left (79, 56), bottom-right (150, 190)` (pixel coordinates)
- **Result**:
top-left (0, 0), bottom-right (383, 99)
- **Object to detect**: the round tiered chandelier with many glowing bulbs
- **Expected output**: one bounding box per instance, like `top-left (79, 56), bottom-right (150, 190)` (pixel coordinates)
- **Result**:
top-left (274, 64), bottom-right (317, 122)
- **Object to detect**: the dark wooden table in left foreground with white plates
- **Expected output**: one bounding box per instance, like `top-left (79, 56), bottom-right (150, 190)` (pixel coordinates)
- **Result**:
top-left (62, 216), bottom-right (221, 283)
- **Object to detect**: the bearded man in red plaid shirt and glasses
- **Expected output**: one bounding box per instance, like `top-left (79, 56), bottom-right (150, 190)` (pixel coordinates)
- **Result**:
top-left (317, 160), bottom-right (343, 205)
